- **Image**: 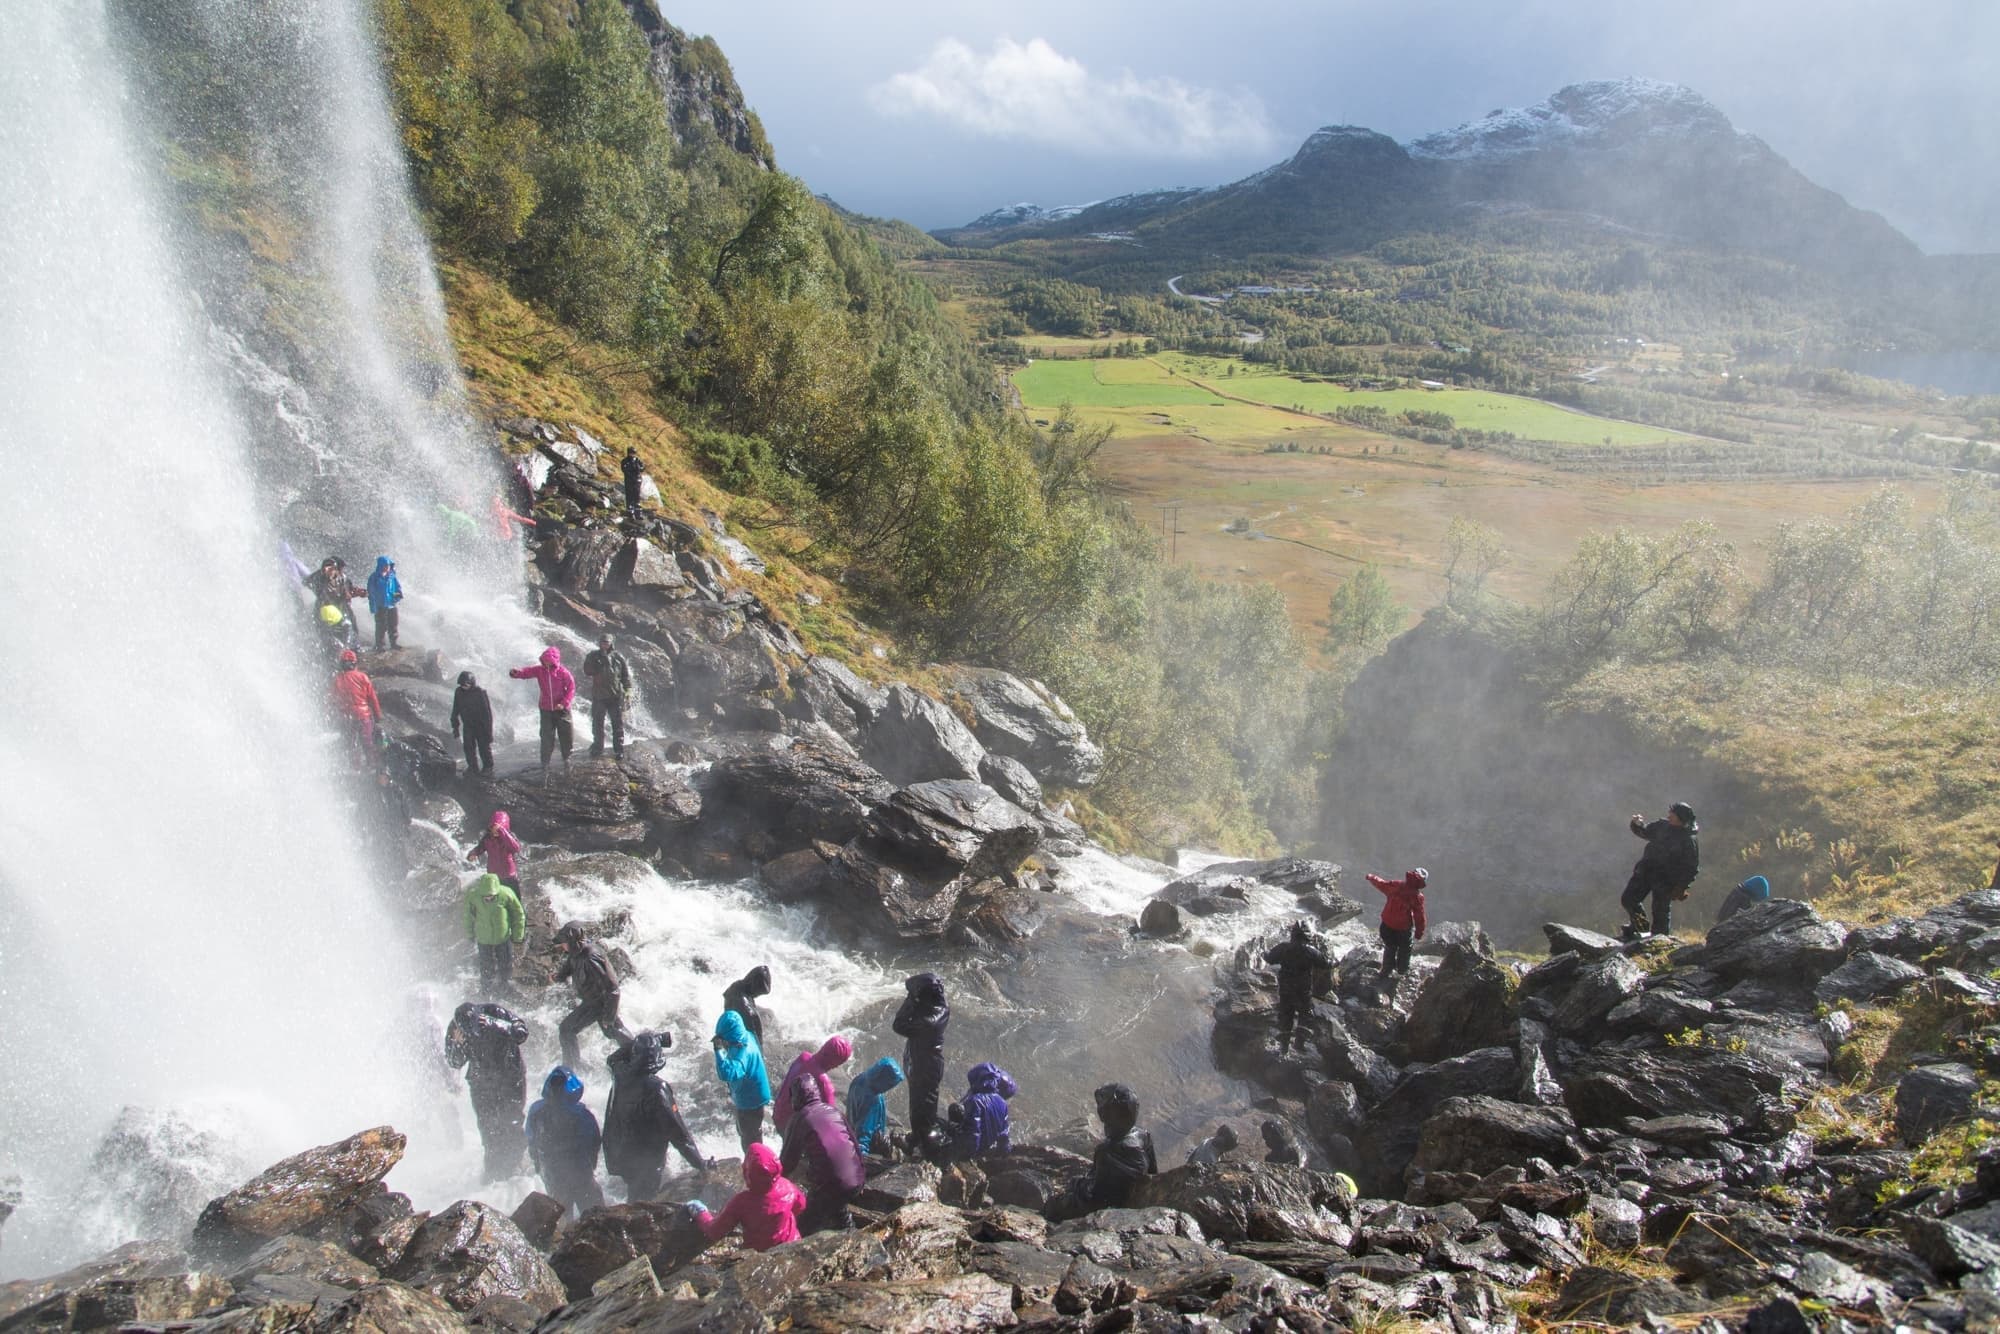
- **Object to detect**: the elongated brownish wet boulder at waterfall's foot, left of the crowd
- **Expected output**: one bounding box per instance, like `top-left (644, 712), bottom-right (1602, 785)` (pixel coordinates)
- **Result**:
top-left (194, 1126), bottom-right (408, 1258)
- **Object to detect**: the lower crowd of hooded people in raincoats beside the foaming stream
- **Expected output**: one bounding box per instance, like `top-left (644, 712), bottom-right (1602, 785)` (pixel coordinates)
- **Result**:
top-left (444, 944), bottom-right (1158, 1250)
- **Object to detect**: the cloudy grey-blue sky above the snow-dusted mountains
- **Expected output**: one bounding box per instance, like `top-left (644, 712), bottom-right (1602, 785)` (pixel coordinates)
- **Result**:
top-left (662, 0), bottom-right (2000, 252)
